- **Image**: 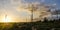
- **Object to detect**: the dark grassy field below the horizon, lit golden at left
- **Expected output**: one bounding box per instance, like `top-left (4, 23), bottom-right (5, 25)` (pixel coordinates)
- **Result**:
top-left (0, 20), bottom-right (60, 30)
